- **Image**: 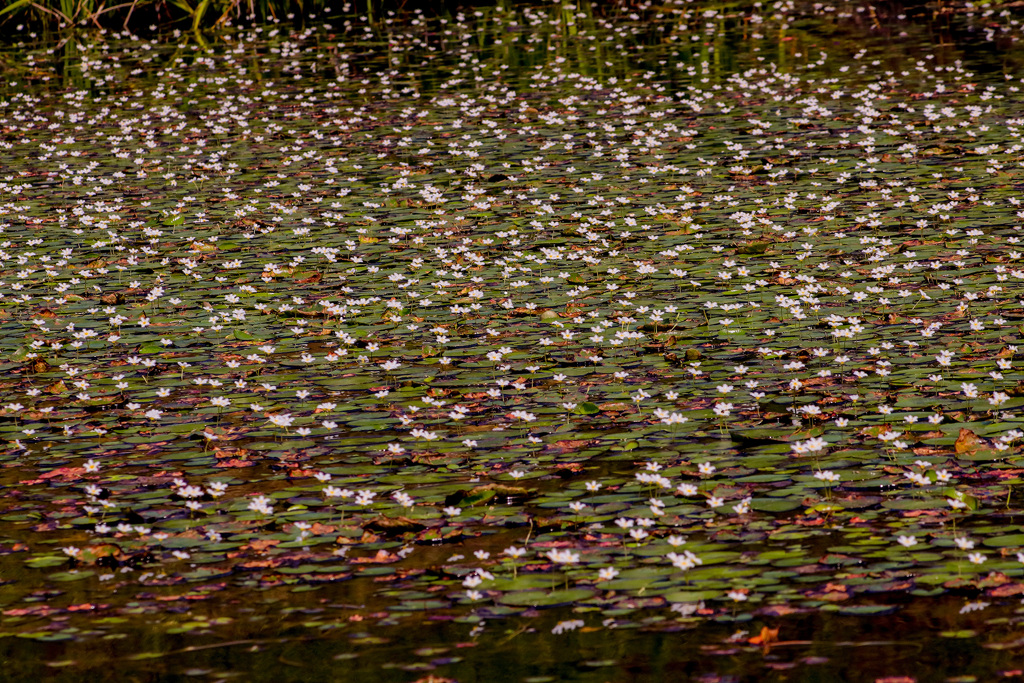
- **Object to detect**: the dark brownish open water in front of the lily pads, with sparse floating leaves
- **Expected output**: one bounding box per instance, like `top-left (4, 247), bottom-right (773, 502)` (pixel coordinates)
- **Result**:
top-left (2, 593), bottom-right (1019, 683)
